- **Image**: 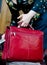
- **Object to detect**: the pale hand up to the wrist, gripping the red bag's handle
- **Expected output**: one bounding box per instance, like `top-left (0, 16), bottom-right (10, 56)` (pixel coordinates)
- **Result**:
top-left (18, 14), bottom-right (30, 27)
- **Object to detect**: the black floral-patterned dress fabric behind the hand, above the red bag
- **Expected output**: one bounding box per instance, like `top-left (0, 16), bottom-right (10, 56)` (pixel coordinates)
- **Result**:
top-left (6, 0), bottom-right (33, 26)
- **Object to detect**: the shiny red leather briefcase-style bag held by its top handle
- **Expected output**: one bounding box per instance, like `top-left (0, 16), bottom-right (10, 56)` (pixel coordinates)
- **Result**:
top-left (2, 27), bottom-right (44, 61)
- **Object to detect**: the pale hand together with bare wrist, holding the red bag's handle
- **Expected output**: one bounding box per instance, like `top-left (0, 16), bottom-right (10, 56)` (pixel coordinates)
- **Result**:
top-left (18, 10), bottom-right (36, 27)
